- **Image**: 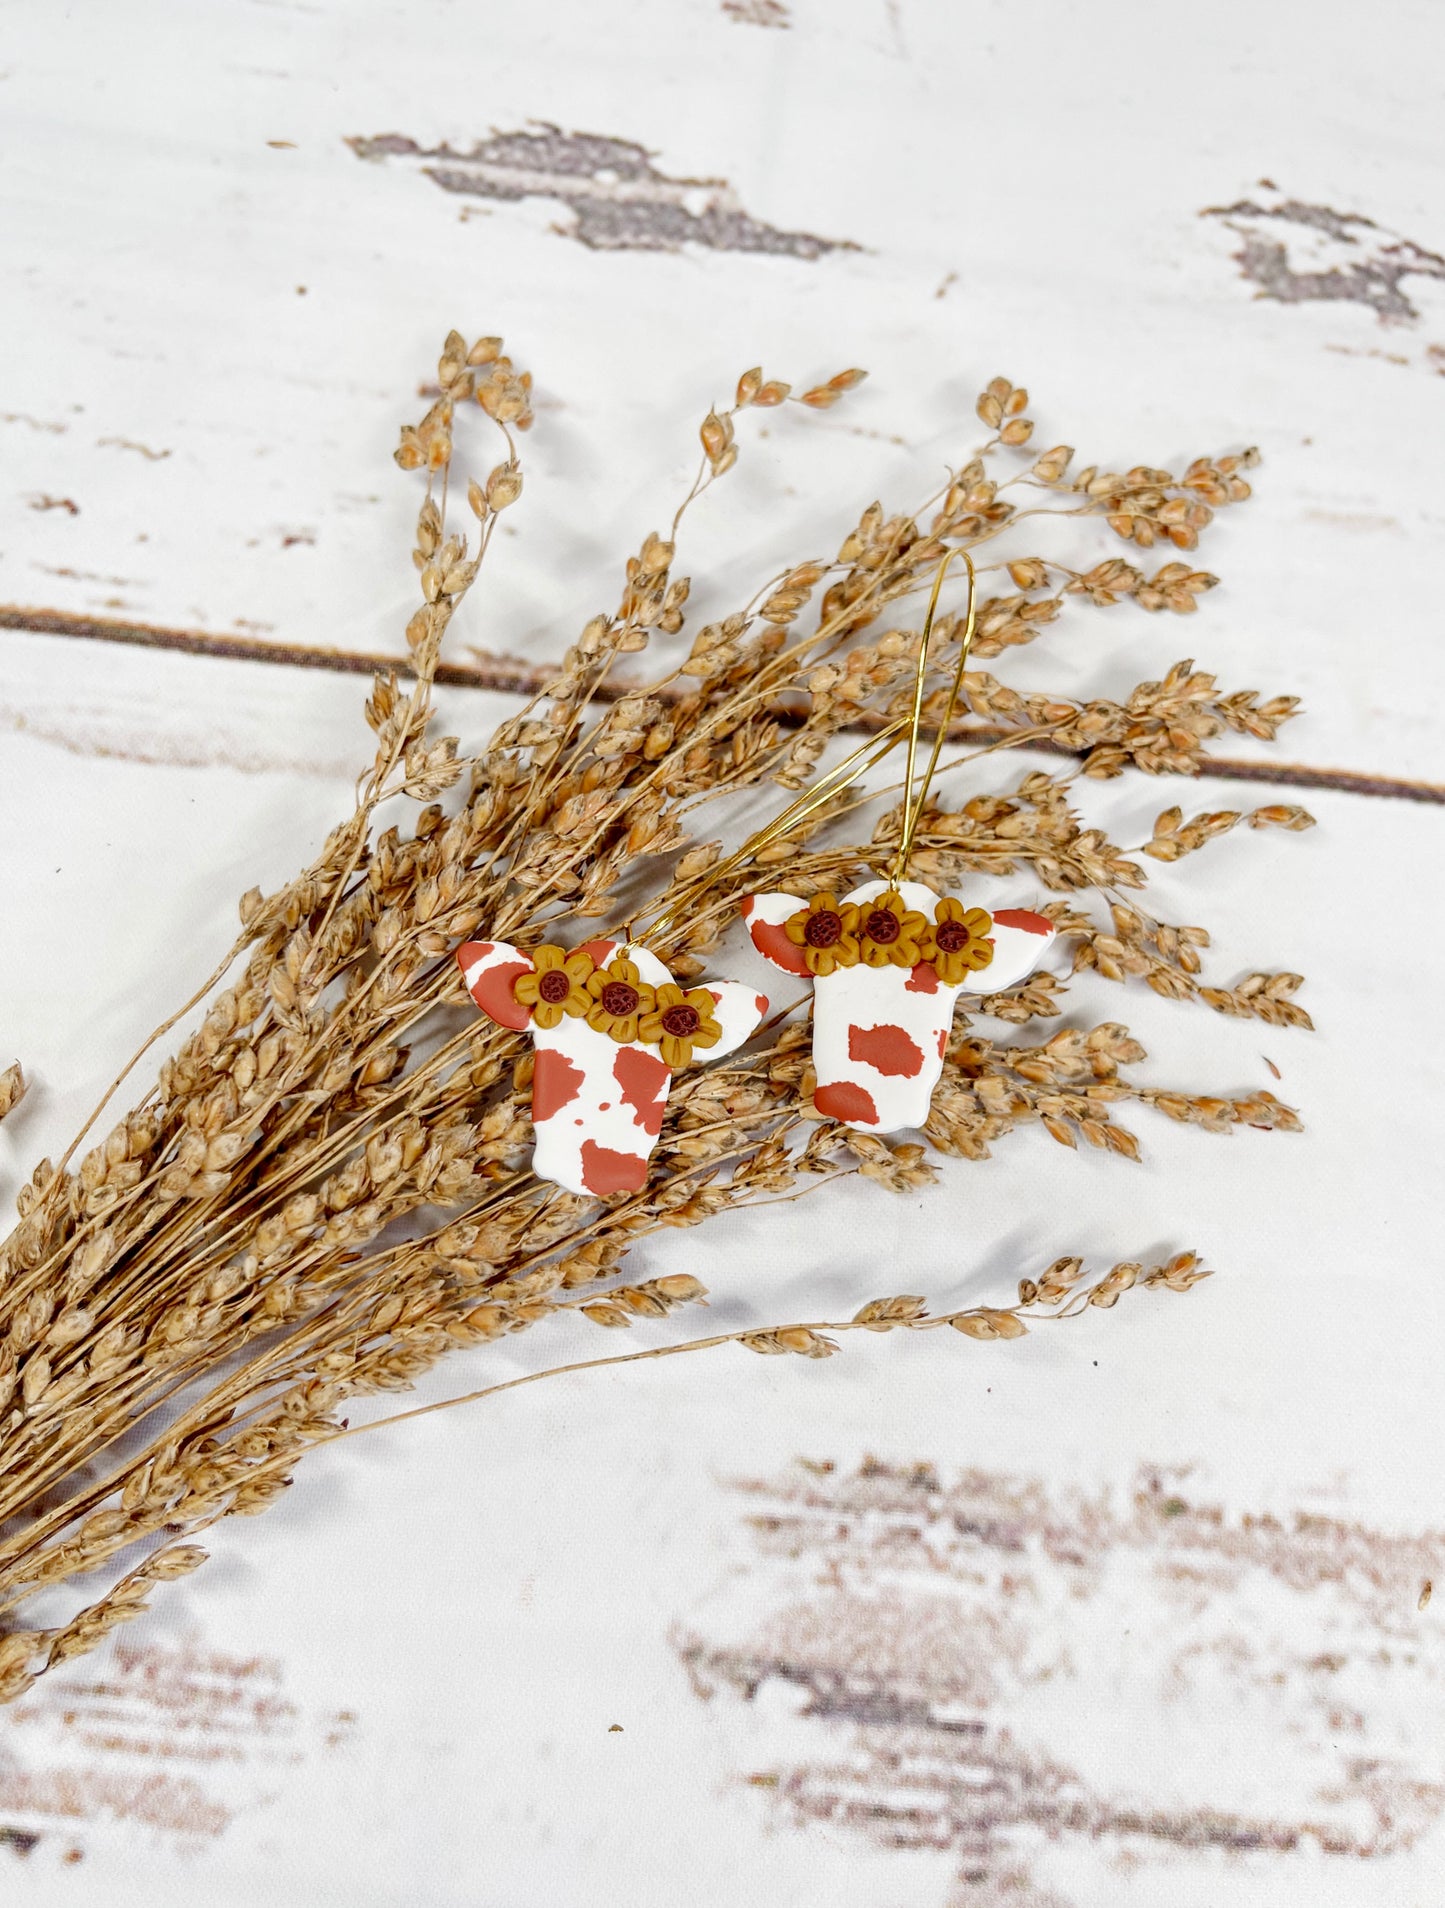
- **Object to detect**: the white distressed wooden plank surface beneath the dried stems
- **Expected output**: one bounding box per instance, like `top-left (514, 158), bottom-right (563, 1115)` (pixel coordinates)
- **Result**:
top-left (0, 0), bottom-right (1445, 1908)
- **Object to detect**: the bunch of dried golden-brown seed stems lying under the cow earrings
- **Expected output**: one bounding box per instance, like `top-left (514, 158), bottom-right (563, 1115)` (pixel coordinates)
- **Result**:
top-left (0, 332), bottom-right (1309, 1696)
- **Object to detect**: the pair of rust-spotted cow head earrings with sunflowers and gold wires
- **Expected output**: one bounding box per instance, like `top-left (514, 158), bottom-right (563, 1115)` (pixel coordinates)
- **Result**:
top-left (456, 553), bottom-right (1056, 1196)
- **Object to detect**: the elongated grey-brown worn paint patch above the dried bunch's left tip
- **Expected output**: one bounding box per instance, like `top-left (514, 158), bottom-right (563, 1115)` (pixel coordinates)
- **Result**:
top-left (346, 126), bottom-right (859, 259)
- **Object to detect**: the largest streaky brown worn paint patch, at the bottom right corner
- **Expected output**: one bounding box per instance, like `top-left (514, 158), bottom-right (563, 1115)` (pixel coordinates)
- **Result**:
top-left (678, 1460), bottom-right (1445, 1908)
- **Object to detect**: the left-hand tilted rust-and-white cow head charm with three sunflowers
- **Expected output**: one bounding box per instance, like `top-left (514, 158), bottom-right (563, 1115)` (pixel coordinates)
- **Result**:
top-left (456, 941), bottom-right (767, 1196)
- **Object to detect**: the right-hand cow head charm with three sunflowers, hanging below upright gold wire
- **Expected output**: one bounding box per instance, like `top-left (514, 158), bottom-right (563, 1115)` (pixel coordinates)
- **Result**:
top-left (743, 881), bottom-right (1054, 1133)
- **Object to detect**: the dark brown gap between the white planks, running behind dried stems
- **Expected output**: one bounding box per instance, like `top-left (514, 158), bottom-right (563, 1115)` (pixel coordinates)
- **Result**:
top-left (0, 603), bottom-right (1445, 805)
